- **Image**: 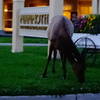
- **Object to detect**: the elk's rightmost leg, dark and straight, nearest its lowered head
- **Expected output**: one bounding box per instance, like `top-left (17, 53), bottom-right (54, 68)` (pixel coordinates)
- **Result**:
top-left (60, 51), bottom-right (66, 79)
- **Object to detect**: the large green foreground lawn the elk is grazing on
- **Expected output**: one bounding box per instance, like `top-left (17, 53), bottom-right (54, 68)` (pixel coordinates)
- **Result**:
top-left (0, 46), bottom-right (100, 95)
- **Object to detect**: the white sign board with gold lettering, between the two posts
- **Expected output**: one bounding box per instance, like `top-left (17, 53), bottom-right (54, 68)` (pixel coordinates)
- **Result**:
top-left (19, 7), bottom-right (49, 37)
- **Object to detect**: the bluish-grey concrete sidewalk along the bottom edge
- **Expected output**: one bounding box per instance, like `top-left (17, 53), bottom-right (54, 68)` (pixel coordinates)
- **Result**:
top-left (0, 93), bottom-right (100, 100)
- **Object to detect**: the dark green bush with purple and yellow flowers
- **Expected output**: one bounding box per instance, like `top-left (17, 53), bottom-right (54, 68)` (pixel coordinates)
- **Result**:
top-left (75, 14), bottom-right (100, 34)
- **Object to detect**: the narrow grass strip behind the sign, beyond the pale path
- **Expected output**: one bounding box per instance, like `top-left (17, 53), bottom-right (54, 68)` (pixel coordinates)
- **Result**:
top-left (0, 37), bottom-right (48, 43)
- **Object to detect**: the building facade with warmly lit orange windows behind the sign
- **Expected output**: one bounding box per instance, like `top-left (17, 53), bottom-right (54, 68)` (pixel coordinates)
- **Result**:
top-left (0, 0), bottom-right (100, 31)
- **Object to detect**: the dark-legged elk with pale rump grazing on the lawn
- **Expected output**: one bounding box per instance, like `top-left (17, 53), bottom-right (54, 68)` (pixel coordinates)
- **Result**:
top-left (43, 15), bottom-right (85, 83)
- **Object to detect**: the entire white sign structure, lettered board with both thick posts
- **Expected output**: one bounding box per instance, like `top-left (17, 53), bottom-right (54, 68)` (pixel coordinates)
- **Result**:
top-left (12, 0), bottom-right (64, 53)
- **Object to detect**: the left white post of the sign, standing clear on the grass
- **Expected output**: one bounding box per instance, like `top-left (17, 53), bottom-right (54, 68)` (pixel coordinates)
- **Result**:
top-left (12, 0), bottom-right (25, 53)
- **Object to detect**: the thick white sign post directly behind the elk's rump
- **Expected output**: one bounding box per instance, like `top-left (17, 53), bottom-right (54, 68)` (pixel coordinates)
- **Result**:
top-left (48, 0), bottom-right (64, 58)
